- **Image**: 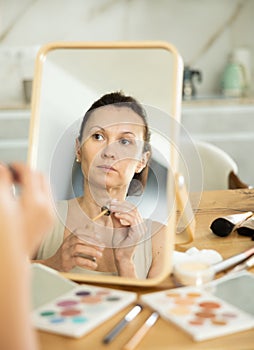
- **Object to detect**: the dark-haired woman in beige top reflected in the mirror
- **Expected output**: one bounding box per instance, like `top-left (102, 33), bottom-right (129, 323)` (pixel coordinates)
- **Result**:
top-left (36, 92), bottom-right (168, 278)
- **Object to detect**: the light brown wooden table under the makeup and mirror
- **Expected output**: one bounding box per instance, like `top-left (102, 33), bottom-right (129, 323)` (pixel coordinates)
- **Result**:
top-left (37, 189), bottom-right (254, 350)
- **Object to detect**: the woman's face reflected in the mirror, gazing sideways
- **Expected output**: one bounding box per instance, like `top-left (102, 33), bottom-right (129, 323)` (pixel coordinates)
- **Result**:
top-left (77, 105), bottom-right (149, 194)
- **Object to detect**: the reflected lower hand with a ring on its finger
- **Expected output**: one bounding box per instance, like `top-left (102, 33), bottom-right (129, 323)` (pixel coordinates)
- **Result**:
top-left (44, 225), bottom-right (104, 272)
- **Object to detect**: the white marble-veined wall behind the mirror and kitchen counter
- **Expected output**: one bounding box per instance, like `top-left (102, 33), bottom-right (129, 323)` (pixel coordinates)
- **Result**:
top-left (0, 0), bottom-right (254, 105)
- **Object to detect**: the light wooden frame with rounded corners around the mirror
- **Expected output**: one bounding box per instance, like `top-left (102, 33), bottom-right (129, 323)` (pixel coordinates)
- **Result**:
top-left (28, 42), bottom-right (186, 286)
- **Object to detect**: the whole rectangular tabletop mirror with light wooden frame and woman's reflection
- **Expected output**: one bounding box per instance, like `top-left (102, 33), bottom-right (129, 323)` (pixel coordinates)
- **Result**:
top-left (28, 42), bottom-right (183, 286)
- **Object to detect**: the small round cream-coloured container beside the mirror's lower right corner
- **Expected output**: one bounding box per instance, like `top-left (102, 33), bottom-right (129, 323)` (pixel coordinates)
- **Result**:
top-left (173, 261), bottom-right (214, 286)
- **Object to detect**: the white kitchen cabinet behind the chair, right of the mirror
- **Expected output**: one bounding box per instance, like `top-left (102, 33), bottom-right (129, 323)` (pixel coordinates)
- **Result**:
top-left (182, 99), bottom-right (254, 186)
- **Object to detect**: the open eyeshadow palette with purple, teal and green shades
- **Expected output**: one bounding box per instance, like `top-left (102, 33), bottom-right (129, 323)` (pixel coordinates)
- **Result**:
top-left (32, 264), bottom-right (137, 338)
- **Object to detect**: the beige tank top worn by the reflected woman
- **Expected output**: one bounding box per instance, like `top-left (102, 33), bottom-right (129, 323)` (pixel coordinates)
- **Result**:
top-left (36, 201), bottom-right (152, 279)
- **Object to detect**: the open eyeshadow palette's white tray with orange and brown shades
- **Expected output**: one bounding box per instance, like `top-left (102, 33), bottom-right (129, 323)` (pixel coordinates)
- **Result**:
top-left (141, 287), bottom-right (254, 341)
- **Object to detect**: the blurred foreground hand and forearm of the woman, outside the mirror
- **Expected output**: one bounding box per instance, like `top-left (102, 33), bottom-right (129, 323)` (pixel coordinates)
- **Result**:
top-left (0, 164), bottom-right (53, 350)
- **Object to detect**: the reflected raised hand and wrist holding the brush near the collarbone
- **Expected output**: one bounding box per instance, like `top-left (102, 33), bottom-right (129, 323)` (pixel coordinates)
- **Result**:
top-left (110, 200), bottom-right (146, 277)
